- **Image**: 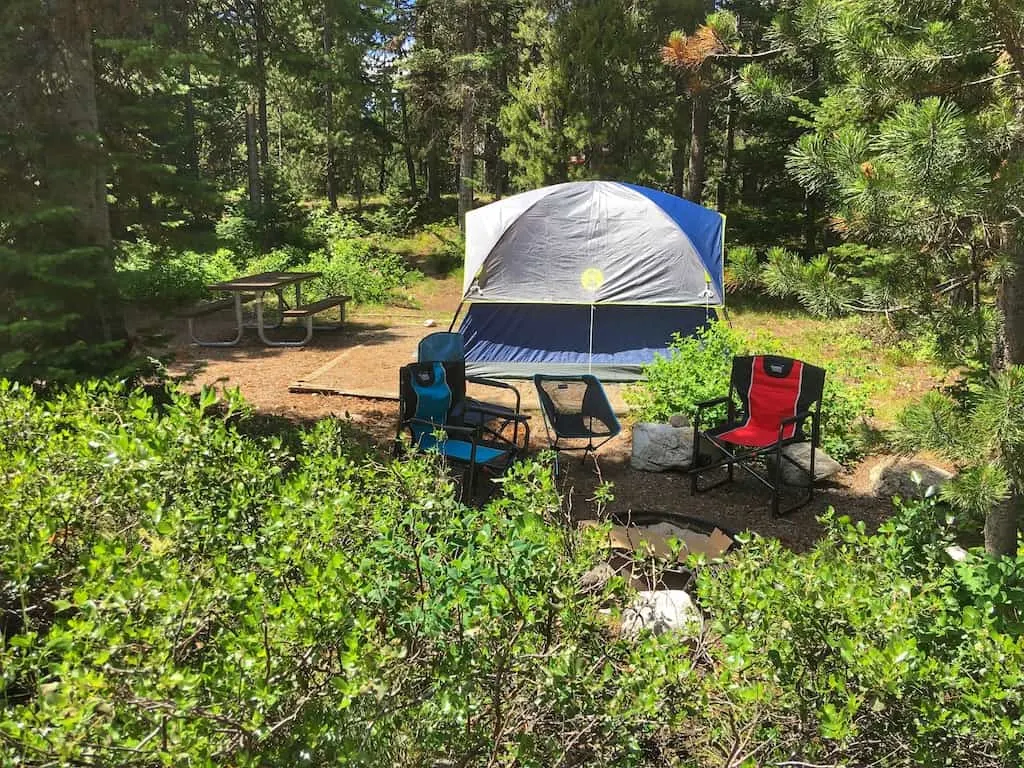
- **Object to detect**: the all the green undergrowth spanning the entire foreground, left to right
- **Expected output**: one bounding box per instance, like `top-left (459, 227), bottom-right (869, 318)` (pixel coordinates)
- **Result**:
top-left (0, 384), bottom-right (1024, 768)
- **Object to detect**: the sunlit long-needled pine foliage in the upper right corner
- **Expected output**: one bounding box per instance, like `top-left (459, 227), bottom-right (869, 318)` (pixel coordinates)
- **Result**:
top-left (774, 0), bottom-right (1024, 554)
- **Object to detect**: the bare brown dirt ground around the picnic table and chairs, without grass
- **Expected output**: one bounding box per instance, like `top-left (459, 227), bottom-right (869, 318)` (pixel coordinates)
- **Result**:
top-left (150, 280), bottom-right (905, 550)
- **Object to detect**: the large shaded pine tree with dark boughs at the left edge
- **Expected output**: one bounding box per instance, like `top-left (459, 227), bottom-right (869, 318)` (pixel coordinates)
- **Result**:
top-left (0, 0), bottom-right (129, 383)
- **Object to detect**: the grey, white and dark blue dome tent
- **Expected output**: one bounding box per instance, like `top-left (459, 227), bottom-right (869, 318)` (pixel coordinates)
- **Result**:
top-left (453, 181), bottom-right (725, 381)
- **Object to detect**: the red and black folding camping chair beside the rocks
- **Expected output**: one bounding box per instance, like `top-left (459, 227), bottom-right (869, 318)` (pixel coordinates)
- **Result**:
top-left (690, 354), bottom-right (825, 516)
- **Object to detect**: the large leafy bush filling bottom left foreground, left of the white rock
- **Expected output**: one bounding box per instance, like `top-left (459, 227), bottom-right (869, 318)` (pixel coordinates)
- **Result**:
top-left (0, 384), bottom-right (691, 766)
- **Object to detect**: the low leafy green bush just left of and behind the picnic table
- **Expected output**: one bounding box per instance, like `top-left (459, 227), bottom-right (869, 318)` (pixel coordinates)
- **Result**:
top-left (117, 241), bottom-right (236, 305)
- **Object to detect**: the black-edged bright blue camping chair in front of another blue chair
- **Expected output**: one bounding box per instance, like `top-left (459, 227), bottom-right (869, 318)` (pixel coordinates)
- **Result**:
top-left (395, 360), bottom-right (516, 496)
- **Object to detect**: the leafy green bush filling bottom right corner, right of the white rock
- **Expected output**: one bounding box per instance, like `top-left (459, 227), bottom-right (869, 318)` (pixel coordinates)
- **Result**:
top-left (693, 501), bottom-right (1024, 768)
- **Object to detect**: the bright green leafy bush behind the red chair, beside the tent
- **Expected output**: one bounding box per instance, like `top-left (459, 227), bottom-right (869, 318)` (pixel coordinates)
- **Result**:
top-left (625, 322), bottom-right (869, 462)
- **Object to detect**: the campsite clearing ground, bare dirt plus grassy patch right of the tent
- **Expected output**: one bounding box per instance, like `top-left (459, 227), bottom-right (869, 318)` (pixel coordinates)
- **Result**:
top-left (165, 275), bottom-right (935, 550)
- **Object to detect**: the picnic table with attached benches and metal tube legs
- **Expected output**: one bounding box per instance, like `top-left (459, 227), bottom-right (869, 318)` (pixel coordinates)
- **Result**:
top-left (184, 272), bottom-right (350, 347)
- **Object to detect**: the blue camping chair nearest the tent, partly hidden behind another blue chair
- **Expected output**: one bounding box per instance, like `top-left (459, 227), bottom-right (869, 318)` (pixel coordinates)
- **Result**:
top-left (416, 331), bottom-right (529, 450)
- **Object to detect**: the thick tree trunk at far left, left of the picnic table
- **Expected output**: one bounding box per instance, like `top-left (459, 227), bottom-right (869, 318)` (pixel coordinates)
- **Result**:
top-left (47, 2), bottom-right (128, 345)
